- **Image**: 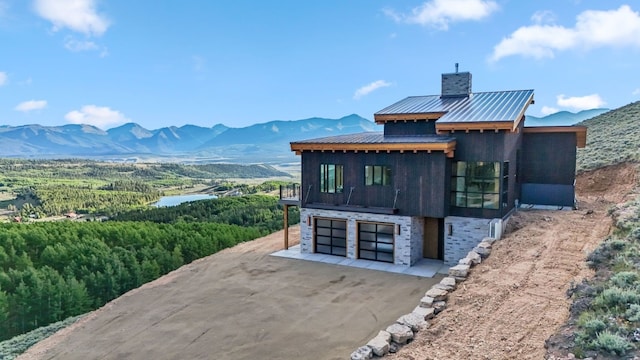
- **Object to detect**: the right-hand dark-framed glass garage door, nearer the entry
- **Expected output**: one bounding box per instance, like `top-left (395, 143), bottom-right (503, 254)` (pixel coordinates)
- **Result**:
top-left (358, 222), bottom-right (393, 263)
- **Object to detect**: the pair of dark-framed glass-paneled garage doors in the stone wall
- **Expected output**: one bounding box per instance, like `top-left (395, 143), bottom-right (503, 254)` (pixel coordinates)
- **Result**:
top-left (314, 219), bottom-right (394, 263)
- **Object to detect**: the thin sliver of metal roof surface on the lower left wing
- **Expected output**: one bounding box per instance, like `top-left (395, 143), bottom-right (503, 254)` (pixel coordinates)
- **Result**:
top-left (291, 132), bottom-right (456, 144)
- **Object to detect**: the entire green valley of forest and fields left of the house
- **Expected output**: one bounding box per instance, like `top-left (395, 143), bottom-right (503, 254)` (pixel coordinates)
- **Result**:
top-left (0, 159), bottom-right (299, 341)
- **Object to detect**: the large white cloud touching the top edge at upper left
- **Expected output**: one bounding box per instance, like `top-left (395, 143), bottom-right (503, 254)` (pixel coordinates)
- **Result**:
top-left (34, 0), bottom-right (110, 36)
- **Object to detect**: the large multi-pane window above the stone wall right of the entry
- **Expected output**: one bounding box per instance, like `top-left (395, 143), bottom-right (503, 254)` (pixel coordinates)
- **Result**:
top-left (451, 161), bottom-right (501, 209)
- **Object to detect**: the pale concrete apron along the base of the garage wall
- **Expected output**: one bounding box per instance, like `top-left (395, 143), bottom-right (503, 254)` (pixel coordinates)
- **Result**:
top-left (271, 245), bottom-right (449, 278)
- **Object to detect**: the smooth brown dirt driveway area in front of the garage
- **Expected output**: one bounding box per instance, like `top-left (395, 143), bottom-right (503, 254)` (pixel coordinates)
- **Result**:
top-left (19, 227), bottom-right (439, 360)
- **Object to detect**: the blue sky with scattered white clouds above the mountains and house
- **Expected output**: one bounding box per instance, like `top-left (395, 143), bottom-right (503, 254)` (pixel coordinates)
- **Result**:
top-left (0, 0), bottom-right (640, 129)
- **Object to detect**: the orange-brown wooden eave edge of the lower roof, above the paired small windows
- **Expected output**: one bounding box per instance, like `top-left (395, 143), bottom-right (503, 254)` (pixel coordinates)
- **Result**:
top-left (291, 140), bottom-right (456, 157)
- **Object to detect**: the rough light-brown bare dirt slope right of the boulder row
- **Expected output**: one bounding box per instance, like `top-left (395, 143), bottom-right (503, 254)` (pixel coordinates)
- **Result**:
top-left (391, 164), bottom-right (637, 360)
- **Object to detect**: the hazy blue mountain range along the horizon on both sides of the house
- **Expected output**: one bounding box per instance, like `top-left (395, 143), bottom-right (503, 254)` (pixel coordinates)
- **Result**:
top-left (0, 109), bottom-right (608, 163)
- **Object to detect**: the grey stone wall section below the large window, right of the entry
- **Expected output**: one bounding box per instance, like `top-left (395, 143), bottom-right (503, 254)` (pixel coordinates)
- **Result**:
top-left (444, 216), bottom-right (491, 266)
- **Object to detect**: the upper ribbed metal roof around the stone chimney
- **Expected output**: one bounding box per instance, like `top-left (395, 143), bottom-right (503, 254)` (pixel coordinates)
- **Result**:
top-left (374, 90), bottom-right (533, 123)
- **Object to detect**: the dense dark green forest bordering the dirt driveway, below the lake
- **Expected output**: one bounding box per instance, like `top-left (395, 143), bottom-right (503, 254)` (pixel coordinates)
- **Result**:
top-left (0, 196), bottom-right (295, 340)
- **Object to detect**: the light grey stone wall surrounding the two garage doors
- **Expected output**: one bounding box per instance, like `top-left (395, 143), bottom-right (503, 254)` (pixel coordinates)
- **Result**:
top-left (300, 208), bottom-right (423, 266)
